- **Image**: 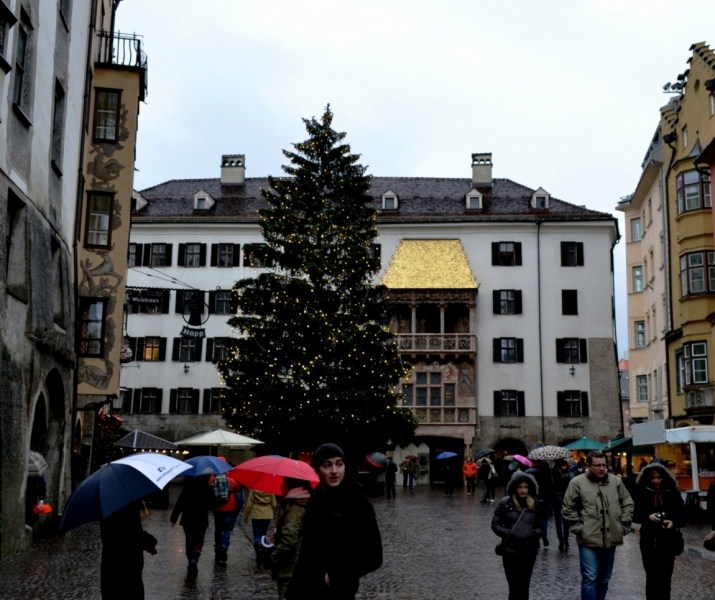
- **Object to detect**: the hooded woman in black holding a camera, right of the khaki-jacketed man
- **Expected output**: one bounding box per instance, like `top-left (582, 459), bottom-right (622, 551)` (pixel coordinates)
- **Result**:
top-left (633, 463), bottom-right (685, 600)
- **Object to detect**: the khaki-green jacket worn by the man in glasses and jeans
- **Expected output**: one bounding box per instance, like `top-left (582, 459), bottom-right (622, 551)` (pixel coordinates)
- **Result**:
top-left (562, 473), bottom-right (633, 548)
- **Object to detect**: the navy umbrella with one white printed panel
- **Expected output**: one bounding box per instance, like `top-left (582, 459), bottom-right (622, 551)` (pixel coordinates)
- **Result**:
top-left (60, 452), bottom-right (191, 531)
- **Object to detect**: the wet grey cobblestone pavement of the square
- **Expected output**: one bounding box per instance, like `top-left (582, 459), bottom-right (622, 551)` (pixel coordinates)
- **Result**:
top-left (0, 488), bottom-right (715, 600)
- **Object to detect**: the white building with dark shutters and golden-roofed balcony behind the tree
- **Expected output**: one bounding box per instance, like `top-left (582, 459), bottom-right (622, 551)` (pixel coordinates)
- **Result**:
top-left (122, 154), bottom-right (622, 481)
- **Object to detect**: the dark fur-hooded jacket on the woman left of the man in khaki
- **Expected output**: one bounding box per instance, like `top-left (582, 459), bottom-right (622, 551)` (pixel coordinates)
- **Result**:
top-left (492, 471), bottom-right (544, 554)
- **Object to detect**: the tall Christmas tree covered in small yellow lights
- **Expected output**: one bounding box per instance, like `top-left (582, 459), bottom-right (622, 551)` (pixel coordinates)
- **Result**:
top-left (218, 106), bottom-right (416, 450)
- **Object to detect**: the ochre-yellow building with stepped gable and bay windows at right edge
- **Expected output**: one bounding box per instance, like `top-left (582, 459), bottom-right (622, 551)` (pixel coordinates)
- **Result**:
top-left (661, 43), bottom-right (715, 427)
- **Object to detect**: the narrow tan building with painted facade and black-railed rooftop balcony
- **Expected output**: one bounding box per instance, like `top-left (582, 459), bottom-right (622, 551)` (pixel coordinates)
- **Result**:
top-left (75, 0), bottom-right (147, 473)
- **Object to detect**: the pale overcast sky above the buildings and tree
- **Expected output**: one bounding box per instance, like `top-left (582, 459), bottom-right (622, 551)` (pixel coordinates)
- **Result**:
top-left (116, 0), bottom-right (715, 355)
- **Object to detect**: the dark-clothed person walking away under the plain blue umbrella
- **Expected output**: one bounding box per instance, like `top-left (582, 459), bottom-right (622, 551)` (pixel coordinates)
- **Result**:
top-left (169, 476), bottom-right (213, 575)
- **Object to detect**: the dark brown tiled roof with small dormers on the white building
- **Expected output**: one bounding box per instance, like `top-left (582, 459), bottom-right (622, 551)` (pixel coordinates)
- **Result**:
top-left (132, 177), bottom-right (614, 223)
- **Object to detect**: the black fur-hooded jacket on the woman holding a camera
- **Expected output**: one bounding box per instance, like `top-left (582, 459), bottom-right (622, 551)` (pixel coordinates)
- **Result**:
top-left (633, 463), bottom-right (686, 544)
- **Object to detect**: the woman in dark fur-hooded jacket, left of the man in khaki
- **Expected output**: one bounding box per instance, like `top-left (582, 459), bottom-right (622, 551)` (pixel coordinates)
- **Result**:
top-left (492, 471), bottom-right (544, 600)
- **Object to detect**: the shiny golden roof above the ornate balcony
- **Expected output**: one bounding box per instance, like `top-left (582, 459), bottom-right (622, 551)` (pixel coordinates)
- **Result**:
top-left (382, 240), bottom-right (477, 290)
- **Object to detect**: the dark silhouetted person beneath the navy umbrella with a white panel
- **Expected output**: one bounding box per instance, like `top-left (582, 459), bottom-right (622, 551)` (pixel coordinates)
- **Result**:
top-left (99, 501), bottom-right (157, 600)
